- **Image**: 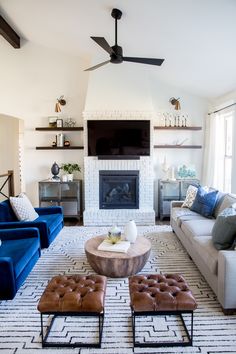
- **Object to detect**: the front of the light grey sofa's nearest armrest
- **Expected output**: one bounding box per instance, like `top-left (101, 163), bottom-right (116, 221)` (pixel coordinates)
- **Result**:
top-left (218, 250), bottom-right (236, 309)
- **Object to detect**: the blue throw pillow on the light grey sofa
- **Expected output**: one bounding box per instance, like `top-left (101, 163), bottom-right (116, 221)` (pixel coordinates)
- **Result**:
top-left (190, 187), bottom-right (218, 218)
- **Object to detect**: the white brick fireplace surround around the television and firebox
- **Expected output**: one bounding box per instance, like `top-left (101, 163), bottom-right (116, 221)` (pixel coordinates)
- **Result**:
top-left (83, 111), bottom-right (155, 226)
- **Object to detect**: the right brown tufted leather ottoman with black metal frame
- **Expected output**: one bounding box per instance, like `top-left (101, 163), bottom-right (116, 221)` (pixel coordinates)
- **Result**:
top-left (129, 274), bottom-right (197, 347)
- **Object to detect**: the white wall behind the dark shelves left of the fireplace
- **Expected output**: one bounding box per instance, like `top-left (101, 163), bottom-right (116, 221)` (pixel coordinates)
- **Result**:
top-left (0, 37), bottom-right (87, 205)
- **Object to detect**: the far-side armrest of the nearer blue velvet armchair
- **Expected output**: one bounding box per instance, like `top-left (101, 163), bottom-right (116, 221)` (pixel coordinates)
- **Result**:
top-left (0, 227), bottom-right (40, 241)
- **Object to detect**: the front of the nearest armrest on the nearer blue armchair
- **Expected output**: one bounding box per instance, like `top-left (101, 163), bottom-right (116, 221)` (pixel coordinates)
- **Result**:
top-left (0, 257), bottom-right (16, 299)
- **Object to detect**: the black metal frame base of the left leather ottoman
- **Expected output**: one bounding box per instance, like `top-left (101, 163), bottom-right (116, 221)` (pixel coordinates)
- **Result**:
top-left (40, 310), bottom-right (104, 348)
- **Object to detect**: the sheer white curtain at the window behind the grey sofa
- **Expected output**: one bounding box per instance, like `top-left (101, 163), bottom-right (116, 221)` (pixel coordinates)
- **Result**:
top-left (202, 112), bottom-right (225, 190)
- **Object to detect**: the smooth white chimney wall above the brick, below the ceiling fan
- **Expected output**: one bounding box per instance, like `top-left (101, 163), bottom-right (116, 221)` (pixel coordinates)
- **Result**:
top-left (85, 63), bottom-right (152, 111)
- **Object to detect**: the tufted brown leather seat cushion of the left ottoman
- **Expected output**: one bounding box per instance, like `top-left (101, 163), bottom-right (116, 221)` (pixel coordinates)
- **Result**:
top-left (38, 275), bottom-right (107, 313)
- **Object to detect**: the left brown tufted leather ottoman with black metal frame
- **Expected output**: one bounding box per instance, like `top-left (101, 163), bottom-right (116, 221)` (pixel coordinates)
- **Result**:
top-left (38, 275), bottom-right (107, 348)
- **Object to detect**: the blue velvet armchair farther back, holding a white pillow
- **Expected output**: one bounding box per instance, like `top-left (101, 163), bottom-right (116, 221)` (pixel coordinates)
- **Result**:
top-left (0, 199), bottom-right (64, 248)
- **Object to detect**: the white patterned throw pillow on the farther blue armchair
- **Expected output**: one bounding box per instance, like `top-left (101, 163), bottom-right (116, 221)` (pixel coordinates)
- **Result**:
top-left (10, 193), bottom-right (39, 221)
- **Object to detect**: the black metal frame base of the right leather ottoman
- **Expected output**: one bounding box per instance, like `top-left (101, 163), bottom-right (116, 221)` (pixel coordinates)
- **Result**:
top-left (131, 307), bottom-right (193, 348)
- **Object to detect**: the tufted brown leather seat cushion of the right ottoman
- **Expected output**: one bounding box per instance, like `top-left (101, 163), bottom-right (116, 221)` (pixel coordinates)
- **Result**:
top-left (129, 274), bottom-right (197, 311)
